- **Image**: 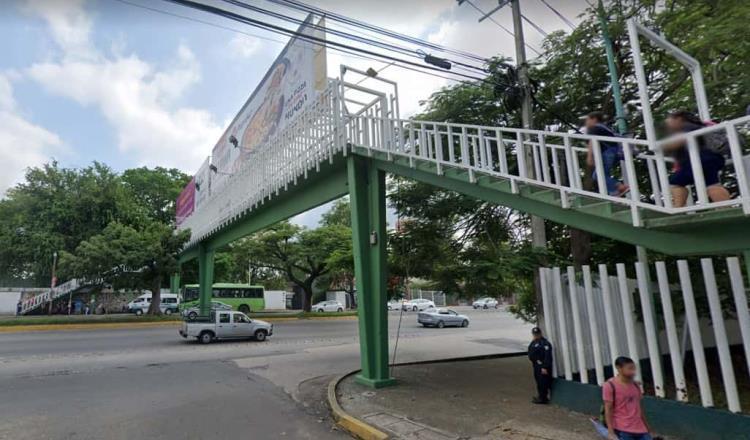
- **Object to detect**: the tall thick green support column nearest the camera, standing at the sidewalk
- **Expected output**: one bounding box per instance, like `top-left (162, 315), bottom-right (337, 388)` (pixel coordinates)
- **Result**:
top-left (347, 155), bottom-right (395, 388)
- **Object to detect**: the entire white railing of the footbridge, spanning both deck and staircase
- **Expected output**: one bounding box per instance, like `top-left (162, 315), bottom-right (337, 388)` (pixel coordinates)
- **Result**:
top-left (180, 75), bottom-right (750, 246)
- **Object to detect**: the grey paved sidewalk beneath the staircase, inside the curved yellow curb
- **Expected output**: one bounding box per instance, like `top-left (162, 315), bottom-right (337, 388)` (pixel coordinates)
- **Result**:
top-left (337, 356), bottom-right (599, 440)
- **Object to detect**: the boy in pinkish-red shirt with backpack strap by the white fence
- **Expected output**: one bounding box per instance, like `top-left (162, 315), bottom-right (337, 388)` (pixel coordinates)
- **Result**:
top-left (602, 356), bottom-right (651, 440)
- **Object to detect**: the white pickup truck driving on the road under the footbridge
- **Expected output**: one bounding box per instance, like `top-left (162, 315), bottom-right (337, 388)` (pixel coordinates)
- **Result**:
top-left (180, 310), bottom-right (273, 344)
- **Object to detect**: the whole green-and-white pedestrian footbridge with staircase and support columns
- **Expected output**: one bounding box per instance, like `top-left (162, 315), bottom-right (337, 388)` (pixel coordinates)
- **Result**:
top-left (180, 75), bottom-right (750, 386)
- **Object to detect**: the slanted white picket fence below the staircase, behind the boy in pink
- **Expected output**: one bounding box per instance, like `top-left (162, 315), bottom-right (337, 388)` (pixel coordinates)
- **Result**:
top-left (540, 257), bottom-right (750, 412)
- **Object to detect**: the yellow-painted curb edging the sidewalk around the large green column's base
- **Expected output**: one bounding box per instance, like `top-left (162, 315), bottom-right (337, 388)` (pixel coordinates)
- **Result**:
top-left (327, 352), bottom-right (526, 440)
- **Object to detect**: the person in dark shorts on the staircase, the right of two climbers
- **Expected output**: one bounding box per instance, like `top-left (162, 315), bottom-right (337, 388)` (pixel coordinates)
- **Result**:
top-left (664, 110), bottom-right (731, 208)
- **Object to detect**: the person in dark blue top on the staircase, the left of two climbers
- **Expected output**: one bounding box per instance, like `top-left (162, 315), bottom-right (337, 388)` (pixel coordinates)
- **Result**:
top-left (584, 111), bottom-right (630, 197)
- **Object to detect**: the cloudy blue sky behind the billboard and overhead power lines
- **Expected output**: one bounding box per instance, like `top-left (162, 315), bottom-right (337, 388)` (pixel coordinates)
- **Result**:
top-left (0, 0), bottom-right (588, 224)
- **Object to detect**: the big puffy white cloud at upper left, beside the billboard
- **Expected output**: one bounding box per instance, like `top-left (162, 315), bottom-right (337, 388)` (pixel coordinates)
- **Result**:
top-left (27, 0), bottom-right (222, 172)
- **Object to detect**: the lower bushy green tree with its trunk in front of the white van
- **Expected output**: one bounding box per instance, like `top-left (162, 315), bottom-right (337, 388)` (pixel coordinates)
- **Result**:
top-left (60, 222), bottom-right (189, 315)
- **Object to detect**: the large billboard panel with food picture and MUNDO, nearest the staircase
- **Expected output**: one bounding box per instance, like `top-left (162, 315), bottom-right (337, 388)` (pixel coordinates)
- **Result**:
top-left (211, 16), bottom-right (325, 194)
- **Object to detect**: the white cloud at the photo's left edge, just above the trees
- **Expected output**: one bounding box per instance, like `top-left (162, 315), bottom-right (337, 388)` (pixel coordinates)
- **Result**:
top-left (0, 74), bottom-right (64, 197)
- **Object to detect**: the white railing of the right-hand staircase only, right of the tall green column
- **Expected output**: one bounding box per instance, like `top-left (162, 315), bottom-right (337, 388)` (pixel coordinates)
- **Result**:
top-left (347, 115), bottom-right (750, 226)
